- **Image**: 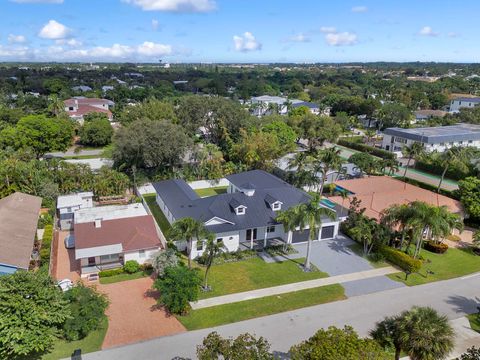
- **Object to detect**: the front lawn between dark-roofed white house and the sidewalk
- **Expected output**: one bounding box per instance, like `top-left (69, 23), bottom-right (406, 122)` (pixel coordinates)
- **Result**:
top-left (200, 257), bottom-right (328, 299)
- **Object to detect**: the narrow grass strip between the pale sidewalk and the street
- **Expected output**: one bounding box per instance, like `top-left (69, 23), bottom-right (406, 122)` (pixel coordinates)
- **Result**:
top-left (177, 284), bottom-right (346, 330)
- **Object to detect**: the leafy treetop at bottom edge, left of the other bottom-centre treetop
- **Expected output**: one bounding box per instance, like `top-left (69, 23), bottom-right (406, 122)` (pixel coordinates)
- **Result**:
top-left (197, 331), bottom-right (274, 360)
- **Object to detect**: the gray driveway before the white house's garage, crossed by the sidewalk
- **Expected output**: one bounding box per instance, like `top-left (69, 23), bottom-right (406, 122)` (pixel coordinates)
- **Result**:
top-left (293, 234), bottom-right (405, 296)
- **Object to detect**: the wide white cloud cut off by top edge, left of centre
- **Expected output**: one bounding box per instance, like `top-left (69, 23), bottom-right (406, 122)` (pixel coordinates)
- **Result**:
top-left (122, 0), bottom-right (216, 13)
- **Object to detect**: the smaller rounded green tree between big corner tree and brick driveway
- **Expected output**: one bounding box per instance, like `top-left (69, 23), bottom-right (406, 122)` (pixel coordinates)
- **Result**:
top-left (63, 282), bottom-right (108, 341)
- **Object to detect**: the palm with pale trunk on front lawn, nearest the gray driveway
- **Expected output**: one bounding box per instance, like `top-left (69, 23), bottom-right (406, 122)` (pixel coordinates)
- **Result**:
top-left (294, 195), bottom-right (336, 271)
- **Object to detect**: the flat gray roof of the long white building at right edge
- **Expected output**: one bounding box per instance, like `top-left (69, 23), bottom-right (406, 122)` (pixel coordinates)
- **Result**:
top-left (385, 124), bottom-right (480, 144)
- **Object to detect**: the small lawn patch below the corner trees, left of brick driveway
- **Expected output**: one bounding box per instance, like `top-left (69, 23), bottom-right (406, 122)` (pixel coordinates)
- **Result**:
top-left (42, 316), bottom-right (108, 360)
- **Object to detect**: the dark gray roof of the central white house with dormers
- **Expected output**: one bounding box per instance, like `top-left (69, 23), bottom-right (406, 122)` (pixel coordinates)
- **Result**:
top-left (153, 170), bottom-right (330, 233)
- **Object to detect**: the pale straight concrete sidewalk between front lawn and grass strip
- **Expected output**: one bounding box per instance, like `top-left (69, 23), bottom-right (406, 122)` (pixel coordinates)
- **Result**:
top-left (190, 266), bottom-right (399, 310)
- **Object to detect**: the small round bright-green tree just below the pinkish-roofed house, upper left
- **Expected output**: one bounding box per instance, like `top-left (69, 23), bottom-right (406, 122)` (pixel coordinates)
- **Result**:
top-left (79, 113), bottom-right (113, 146)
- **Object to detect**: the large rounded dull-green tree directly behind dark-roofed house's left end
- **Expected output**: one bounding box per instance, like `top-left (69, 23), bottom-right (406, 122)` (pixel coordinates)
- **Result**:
top-left (112, 120), bottom-right (191, 169)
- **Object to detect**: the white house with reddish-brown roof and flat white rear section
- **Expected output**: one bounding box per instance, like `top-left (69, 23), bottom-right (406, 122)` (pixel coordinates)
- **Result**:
top-left (74, 204), bottom-right (165, 277)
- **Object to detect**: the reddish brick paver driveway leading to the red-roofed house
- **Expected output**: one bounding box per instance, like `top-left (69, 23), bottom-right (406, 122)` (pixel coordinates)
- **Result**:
top-left (98, 277), bottom-right (185, 348)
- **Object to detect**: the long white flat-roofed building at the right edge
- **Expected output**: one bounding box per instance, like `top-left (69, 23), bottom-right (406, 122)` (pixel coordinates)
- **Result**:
top-left (382, 124), bottom-right (480, 152)
